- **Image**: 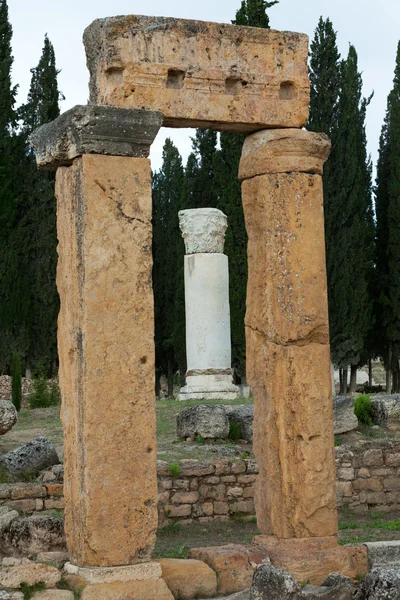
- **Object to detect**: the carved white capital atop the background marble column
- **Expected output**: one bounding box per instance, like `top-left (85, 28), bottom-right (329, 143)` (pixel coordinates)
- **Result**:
top-left (179, 208), bottom-right (228, 254)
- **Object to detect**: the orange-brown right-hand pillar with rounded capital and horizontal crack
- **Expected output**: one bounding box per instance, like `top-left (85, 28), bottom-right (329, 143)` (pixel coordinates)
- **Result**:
top-left (239, 129), bottom-right (358, 580)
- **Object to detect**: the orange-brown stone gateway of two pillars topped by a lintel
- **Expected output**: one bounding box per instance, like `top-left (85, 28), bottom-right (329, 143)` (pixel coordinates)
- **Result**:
top-left (29, 15), bottom-right (364, 600)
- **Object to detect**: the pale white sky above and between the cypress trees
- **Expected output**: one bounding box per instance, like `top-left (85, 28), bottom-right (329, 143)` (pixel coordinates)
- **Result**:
top-left (8, 0), bottom-right (400, 168)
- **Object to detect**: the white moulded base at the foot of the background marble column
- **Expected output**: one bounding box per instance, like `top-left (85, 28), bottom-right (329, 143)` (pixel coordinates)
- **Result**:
top-left (178, 369), bottom-right (239, 400)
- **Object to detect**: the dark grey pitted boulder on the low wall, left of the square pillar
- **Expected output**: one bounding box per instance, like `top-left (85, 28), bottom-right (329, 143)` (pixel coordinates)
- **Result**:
top-left (0, 436), bottom-right (60, 477)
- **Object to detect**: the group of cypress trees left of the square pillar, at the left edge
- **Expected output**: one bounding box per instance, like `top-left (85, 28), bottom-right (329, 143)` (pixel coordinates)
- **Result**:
top-left (0, 0), bottom-right (62, 375)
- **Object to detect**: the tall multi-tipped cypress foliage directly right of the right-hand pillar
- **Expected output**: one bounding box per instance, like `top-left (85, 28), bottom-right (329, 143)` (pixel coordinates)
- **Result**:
top-left (308, 24), bottom-right (375, 376)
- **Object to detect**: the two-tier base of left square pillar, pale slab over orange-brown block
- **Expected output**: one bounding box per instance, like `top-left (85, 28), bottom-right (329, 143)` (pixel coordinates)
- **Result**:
top-left (64, 562), bottom-right (174, 600)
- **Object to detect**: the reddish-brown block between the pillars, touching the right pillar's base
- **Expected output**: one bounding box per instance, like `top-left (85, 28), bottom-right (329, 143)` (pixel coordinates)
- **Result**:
top-left (189, 544), bottom-right (253, 594)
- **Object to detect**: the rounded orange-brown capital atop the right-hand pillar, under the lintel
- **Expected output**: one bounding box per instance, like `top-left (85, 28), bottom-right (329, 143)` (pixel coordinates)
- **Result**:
top-left (239, 129), bottom-right (331, 179)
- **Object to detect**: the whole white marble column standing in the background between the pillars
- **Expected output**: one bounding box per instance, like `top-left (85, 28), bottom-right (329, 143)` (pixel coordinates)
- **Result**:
top-left (179, 208), bottom-right (239, 400)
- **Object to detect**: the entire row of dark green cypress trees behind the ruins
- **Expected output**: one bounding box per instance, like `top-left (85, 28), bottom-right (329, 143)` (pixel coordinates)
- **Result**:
top-left (0, 0), bottom-right (400, 395)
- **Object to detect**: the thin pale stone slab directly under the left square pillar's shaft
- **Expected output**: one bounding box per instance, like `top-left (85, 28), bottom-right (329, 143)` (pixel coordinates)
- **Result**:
top-left (64, 562), bottom-right (162, 585)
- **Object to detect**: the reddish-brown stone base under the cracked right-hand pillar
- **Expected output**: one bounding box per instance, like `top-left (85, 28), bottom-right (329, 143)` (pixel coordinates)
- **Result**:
top-left (250, 536), bottom-right (367, 585)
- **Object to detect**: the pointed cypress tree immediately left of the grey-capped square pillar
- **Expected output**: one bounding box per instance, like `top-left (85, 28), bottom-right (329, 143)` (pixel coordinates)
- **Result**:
top-left (16, 35), bottom-right (63, 373)
